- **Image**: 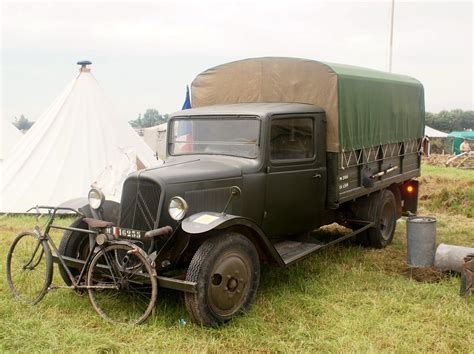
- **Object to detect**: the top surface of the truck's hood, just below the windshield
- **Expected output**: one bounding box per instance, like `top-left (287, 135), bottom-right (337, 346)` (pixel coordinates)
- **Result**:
top-left (140, 159), bottom-right (242, 184)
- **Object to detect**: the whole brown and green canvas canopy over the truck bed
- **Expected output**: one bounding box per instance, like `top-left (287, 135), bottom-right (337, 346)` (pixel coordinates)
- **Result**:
top-left (191, 58), bottom-right (425, 152)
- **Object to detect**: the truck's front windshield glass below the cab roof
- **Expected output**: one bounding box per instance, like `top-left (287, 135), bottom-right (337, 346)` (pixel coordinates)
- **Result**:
top-left (169, 117), bottom-right (260, 158)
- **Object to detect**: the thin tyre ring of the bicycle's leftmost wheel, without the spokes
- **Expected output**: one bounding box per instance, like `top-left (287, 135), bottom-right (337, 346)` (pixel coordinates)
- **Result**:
top-left (6, 232), bottom-right (53, 305)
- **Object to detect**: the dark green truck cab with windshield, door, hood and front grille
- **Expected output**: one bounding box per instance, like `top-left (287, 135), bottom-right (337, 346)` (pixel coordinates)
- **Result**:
top-left (121, 103), bottom-right (327, 236)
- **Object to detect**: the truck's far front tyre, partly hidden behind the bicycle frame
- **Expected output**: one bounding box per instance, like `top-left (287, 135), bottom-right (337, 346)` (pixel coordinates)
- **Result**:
top-left (58, 218), bottom-right (89, 286)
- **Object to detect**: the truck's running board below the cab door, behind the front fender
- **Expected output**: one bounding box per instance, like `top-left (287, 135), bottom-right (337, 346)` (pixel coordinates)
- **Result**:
top-left (274, 220), bottom-right (375, 266)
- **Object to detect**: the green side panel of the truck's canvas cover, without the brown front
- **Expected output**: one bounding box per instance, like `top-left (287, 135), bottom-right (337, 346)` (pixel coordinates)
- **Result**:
top-left (327, 63), bottom-right (425, 151)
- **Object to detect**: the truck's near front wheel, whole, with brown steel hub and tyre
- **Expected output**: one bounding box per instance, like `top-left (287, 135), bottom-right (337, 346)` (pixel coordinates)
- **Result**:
top-left (185, 232), bottom-right (260, 327)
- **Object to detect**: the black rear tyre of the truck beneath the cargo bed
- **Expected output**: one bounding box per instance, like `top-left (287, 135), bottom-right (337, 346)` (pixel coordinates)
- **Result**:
top-left (367, 189), bottom-right (397, 249)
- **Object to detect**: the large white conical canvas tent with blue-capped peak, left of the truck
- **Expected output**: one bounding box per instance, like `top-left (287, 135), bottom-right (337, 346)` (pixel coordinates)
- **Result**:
top-left (0, 62), bottom-right (162, 212)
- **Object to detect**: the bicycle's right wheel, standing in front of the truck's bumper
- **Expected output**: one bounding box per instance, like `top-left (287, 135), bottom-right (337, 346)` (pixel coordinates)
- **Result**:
top-left (87, 244), bottom-right (158, 324)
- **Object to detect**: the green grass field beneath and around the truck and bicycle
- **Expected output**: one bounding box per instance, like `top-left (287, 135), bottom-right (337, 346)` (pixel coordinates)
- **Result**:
top-left (0, 166), bottom-right (474, 352)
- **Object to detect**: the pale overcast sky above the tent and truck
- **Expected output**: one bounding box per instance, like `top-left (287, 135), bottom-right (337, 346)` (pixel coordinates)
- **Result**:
top-left (1, 0), bottom-right (474, 125)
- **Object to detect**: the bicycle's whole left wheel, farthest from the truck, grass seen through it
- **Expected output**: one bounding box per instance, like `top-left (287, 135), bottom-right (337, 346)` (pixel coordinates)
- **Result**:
top-left (7, 232), bottom-right (53, 305)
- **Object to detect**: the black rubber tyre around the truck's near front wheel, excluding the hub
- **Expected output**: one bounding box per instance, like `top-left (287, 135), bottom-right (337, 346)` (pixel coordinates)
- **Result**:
top-left (184, 232), bottom-right (260, 327)
